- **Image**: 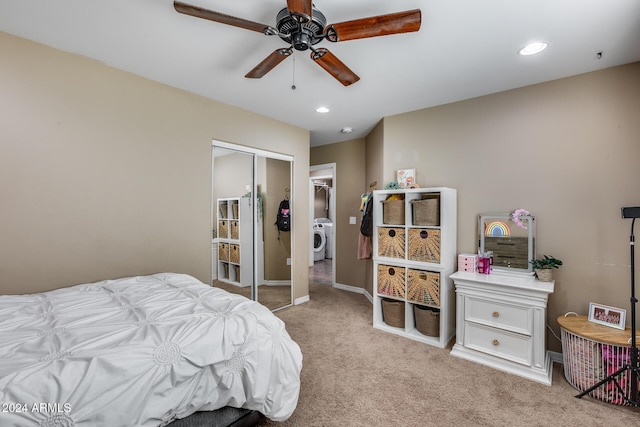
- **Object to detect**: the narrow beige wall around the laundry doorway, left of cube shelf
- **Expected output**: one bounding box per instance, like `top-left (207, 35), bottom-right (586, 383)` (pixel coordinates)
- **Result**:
top-left (311, 139), bottom-right (370, 288)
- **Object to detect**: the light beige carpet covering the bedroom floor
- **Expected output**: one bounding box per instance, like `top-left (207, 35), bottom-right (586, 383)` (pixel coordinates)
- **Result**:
top-left (261, 284), bottom-right (640, 427)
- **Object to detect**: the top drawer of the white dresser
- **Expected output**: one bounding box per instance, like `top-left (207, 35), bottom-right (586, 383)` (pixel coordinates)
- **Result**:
top-left (464, 296), bottom-right (533, 335)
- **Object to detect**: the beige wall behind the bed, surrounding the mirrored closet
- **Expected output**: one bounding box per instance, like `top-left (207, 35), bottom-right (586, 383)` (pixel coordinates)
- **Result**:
top-left (0, 33), bottom-right (309, 298)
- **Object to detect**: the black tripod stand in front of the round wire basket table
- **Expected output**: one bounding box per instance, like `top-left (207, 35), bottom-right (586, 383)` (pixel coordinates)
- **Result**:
top-left (576, 206), bottom-right (640, 406)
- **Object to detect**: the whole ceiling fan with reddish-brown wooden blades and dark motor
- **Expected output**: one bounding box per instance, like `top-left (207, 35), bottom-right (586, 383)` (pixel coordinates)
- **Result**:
top-left (173, 0), bottom-right (422, 86)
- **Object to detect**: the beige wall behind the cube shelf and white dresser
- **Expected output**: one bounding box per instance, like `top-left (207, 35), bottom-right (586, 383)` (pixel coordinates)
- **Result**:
top-left (383, 63), bottom-right (640, 351)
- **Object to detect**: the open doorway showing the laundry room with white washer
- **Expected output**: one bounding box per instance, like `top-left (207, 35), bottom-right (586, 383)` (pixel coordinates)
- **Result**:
top-left (309, 163), bottom-right (336, 286)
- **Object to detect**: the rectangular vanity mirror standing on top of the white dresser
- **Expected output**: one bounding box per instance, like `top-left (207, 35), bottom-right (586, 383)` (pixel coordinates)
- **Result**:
top-left (478, 213), bottom-right (536, 276)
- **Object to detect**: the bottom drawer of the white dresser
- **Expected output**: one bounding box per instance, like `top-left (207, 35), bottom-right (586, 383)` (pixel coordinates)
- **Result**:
top-left (464, 322), bottom-right (533, 366)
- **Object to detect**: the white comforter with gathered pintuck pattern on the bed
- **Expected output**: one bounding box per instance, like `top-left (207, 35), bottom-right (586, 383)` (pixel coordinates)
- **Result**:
top-left (0, 273), bottom-right (302, 427)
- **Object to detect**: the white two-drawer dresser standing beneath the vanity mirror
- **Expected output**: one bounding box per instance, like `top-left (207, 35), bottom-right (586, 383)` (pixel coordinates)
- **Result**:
top-left (450, 271), bottom-right (554, 385)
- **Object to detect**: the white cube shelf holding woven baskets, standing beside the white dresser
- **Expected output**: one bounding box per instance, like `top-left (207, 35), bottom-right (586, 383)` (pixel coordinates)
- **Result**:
top-left (373, 187), bottom-right (457, 348)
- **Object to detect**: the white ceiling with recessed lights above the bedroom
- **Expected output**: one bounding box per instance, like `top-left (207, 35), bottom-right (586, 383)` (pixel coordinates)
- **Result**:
top-left (0, 0), bottom-right (640, 146)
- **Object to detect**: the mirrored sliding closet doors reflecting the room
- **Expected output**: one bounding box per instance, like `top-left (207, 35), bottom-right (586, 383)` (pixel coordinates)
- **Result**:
top-left (211, 145), bottom-right (292, 310)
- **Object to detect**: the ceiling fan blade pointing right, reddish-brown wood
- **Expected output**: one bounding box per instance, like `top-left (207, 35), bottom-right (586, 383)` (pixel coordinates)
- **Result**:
top-left (325, 9), bottom-right (422, 42)
